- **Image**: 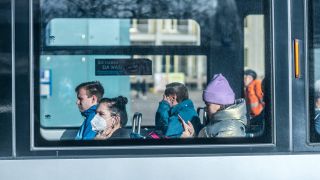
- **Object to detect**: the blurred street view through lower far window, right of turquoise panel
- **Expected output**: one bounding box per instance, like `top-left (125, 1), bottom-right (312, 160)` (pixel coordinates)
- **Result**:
top-left (130, 55), bottom-right (206, 126)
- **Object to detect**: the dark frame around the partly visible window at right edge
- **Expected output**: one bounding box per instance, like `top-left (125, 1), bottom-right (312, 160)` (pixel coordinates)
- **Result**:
top-left (293, 0), bottom-right (320, 152)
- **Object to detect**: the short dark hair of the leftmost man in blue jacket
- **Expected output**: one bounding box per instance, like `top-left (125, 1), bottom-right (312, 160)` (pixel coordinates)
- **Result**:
top-left (75, 81), bottom-right (104, 101)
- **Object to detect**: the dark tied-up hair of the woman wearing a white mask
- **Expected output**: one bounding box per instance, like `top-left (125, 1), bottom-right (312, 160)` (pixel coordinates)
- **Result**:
top-left (99, 96), bottom-right (128, 127)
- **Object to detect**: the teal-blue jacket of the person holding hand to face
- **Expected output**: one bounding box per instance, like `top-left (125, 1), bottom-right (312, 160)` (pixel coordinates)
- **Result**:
top-left (156, 99), bottom-right (201, 138)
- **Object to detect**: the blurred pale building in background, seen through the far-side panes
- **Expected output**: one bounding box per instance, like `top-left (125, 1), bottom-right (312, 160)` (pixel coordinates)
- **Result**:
top-left (130, 15), bottom-right (265, 91)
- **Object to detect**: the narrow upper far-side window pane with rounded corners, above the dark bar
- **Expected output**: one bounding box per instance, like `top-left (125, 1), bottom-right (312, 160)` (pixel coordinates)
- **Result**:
top-left (46, 18), bottom-right (201, 46)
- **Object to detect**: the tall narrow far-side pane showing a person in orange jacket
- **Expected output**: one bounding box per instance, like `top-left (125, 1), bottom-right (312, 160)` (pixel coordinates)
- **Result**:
top-left (244, 15), bottom-right (266, 137)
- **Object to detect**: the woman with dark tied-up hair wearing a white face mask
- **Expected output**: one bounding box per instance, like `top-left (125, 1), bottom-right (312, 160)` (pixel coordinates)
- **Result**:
top-left (91, 96), bottom-right (131, 140)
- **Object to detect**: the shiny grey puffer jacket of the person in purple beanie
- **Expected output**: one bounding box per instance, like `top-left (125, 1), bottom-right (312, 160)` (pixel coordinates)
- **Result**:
top-left (198, 99), bottom-right (247, 137)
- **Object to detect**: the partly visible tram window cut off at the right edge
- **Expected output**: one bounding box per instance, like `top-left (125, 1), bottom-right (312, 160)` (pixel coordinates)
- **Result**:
top-left (308, 1), bottom-right (320, 142)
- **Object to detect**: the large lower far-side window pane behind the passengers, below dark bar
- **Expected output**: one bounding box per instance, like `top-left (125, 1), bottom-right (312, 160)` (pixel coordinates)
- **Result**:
top-left (40, 55), bottom-right (207, 140)
